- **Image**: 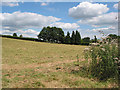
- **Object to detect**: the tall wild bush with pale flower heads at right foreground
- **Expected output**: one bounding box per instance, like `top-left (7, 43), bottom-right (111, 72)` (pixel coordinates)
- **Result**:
top-left (84, 34), bottom-right (118, 80)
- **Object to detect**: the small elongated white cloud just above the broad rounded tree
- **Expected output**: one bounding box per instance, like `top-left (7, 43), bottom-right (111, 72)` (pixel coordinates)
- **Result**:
top-left (50, 22), bottom-right (80, 30)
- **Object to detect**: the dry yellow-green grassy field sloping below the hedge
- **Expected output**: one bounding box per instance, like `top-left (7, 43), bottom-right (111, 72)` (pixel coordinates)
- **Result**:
top-left (2, 38), bottom-right (117, 88)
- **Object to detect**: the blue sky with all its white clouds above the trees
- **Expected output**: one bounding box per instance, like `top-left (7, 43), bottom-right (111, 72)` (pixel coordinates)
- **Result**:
top-left (0, 2), bottom-right (118, 39)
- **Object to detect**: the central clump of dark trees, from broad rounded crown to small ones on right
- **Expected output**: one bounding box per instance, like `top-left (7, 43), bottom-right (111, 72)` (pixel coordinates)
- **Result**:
top-left (38, 26), bottom-right (97, 45)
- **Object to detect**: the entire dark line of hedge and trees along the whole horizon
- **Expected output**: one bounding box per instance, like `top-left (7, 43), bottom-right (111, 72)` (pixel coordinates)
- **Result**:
top-left (0, 26), bottom-right (120, 45)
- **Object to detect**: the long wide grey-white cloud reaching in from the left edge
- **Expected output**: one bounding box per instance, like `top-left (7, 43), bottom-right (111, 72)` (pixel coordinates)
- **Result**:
top-left (0, 12), bottom-right (61, 31)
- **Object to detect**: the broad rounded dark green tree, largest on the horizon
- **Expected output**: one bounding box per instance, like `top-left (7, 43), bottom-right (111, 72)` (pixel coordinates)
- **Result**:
top-left (38, 26), bottom-right (64, 43)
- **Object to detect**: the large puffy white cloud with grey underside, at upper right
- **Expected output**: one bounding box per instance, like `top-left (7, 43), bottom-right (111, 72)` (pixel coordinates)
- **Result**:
top-left (69, 2), bottom-right (109, 19)
